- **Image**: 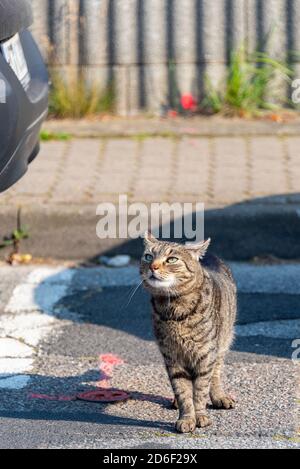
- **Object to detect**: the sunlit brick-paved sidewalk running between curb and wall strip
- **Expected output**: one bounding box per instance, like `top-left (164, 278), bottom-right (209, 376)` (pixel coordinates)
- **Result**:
top-left (0, 136), bottom-right (300, 206)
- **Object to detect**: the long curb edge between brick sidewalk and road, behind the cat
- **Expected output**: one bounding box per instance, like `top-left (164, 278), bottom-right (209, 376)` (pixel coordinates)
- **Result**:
top-left (0, 203), bottom-right (300, 261)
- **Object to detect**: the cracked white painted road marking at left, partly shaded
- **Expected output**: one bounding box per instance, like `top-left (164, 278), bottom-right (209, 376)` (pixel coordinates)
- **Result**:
top-left (0, 268), bottom-right (75, 390)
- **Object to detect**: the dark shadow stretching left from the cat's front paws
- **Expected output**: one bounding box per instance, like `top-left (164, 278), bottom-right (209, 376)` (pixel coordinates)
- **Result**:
top-left (0, 370), bottom-right (174, 432)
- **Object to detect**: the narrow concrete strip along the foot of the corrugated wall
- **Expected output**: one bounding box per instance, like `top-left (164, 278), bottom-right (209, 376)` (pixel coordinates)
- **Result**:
top-left (44, 117), bottom-right (300, 138)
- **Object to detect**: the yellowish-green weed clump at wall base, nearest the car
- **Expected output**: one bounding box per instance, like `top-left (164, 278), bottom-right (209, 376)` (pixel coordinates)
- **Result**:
top-left (49, 72), bottom-right (114, 119)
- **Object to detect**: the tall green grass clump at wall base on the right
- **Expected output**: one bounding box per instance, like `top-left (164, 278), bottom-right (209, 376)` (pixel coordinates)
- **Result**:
top-left (202, 48), bottom-right (293, 117)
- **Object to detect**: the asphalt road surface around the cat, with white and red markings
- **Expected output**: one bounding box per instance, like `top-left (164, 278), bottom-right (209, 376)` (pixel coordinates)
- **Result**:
top-left (0, 264), bottom-right (300, 449)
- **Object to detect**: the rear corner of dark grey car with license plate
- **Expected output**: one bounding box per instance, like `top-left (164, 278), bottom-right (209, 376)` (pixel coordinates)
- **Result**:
top-left (0, 0), bottom-right (49, 192)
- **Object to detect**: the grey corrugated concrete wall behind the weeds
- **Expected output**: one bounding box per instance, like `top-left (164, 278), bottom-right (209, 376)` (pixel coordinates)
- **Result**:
top-left (32, 0), bottom-right (300, 115)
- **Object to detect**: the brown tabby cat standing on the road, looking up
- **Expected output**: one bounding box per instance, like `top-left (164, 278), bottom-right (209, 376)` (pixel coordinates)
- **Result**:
top-left (141, 233), bottom-right (237, 433)
